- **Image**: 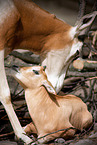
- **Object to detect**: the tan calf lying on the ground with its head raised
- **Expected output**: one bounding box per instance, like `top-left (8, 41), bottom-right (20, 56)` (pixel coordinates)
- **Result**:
top-left (15, 66), bottom-right (92, 143)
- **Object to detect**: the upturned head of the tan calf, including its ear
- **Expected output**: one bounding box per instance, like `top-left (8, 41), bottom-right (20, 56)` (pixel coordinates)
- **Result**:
top-left (12, 66), bottom-right (56, 94)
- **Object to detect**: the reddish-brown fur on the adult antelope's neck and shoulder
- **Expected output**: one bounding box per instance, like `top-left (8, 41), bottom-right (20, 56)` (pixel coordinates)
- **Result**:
top-left (0, 0), bottom-right (72, 54)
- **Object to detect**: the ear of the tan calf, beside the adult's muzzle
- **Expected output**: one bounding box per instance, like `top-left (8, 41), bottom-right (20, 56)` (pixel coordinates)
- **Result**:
top-left (42, 80), bottom-right (57, 95)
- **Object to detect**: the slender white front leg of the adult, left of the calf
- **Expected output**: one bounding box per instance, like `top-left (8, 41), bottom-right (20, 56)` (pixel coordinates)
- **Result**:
top-left (0, 50), bottom-right (32, 144)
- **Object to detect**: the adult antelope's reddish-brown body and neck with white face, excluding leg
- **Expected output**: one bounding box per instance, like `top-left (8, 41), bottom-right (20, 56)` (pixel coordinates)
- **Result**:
top-left (0, 0), bottom-right (79, 92)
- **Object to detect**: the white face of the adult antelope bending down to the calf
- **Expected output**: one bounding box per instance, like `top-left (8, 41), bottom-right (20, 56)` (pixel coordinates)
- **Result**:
top-left (42, 38), bottom-right (83, 92)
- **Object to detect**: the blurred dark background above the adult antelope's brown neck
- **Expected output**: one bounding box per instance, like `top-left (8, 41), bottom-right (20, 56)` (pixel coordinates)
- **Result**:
top-left (32, 0), bottom-right (97, 25)
